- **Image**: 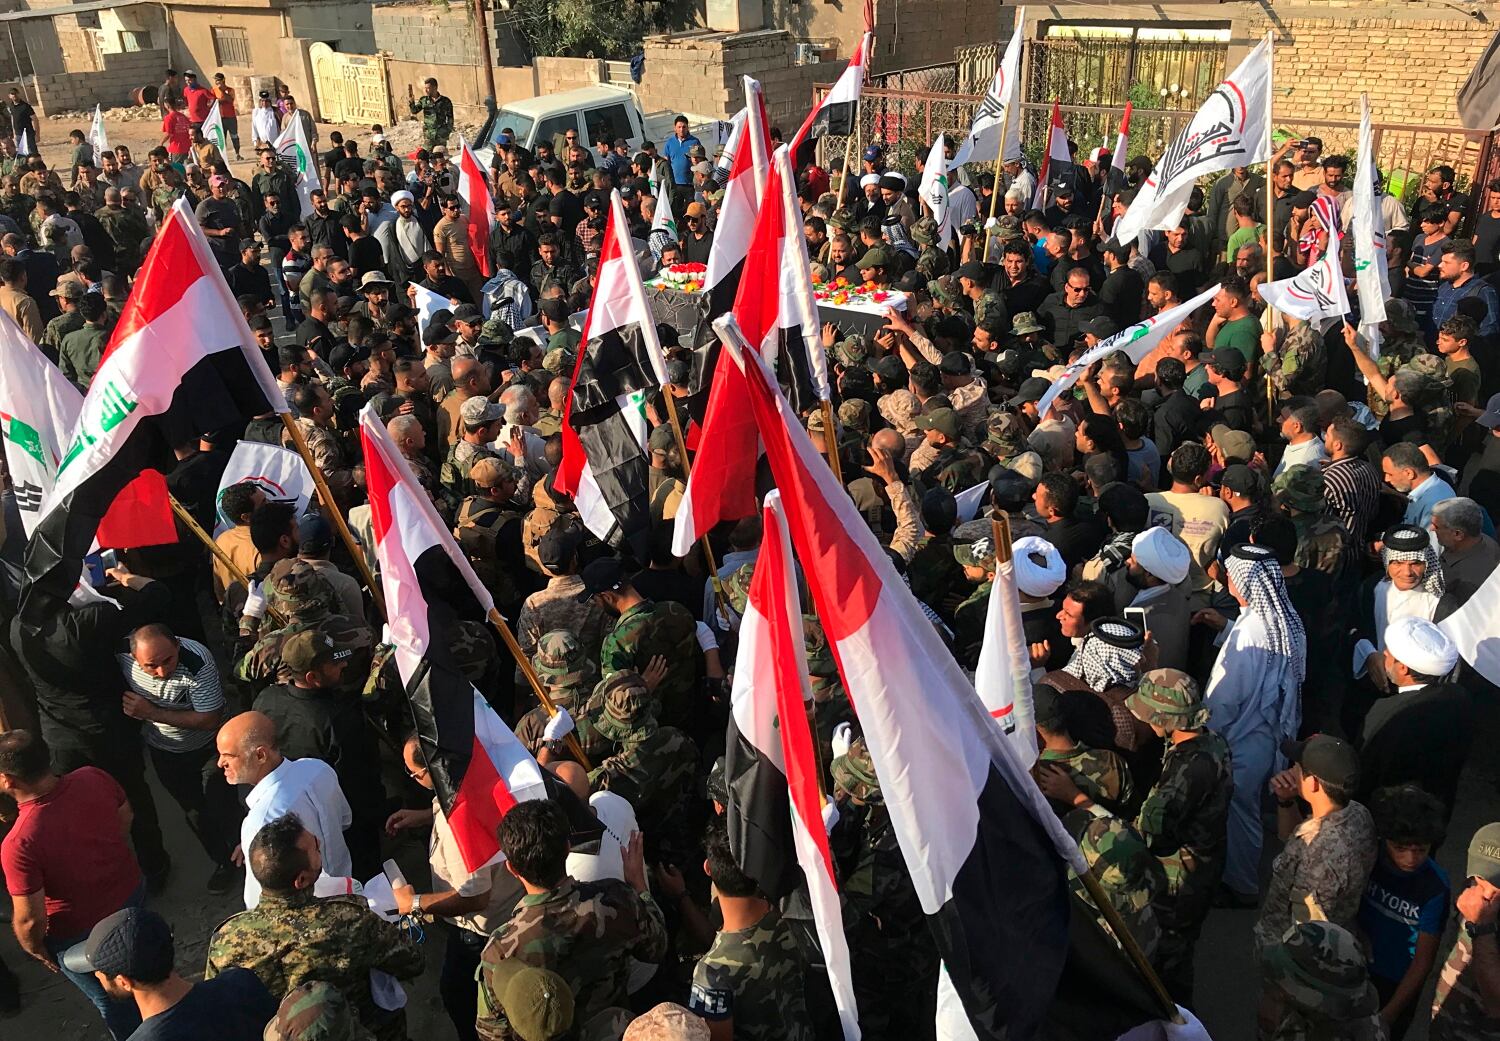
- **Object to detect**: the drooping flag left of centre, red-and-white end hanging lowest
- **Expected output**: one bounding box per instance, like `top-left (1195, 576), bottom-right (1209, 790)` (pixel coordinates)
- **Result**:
top-left (360, 405), bottom-right (548, 872)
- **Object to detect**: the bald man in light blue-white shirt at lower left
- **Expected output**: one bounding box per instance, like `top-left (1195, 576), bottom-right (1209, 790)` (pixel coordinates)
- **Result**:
top-left (215, 713), bottom-right (354, 909)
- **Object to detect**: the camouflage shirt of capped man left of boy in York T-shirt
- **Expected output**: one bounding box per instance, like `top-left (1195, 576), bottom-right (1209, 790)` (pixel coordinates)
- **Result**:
top-left (1254, 803), bottom-right (1377, 953)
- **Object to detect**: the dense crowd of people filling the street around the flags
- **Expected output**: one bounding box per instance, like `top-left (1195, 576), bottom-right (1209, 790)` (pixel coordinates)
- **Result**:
top-left (0, 63), bottom-right (1500, 1041)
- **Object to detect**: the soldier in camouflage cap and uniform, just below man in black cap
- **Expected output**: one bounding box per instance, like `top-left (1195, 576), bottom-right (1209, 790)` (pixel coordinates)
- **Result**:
top-left (579, 672), bottom-right (698, 846)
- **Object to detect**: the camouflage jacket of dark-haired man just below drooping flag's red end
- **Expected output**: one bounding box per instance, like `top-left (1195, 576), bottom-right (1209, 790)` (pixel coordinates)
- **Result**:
top-left (476, 878), bottom-right (668, 1041)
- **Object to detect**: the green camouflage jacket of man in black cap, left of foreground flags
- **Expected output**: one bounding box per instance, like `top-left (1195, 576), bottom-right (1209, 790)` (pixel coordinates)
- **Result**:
top-left (599, 600), bottom-right (704, 726)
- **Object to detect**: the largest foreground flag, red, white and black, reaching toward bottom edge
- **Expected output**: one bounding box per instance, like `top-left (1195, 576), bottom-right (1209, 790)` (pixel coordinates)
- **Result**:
top-left (717, 317), bottom-right (1088, 1041)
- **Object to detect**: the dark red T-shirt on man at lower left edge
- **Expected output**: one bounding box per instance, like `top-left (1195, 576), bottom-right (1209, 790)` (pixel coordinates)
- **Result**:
top-left (0, 767), bottom-right (141, 939)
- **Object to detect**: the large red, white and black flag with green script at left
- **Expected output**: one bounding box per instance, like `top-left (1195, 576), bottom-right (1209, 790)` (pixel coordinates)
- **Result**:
top-left (21, 200), bottom-right (287, 615)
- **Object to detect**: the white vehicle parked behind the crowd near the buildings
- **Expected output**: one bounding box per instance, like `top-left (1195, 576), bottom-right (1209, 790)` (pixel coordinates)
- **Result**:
top-left (474, 84), bottom-right (729, 165)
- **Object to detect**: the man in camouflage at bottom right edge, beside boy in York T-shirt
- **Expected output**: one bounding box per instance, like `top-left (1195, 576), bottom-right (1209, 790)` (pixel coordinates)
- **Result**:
top-left (1428, 824), bottom-right (1500, 1041)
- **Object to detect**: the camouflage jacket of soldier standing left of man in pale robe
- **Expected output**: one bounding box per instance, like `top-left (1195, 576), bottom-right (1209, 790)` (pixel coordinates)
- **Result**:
top-left (1136, 731), bottom-right (1233, 912)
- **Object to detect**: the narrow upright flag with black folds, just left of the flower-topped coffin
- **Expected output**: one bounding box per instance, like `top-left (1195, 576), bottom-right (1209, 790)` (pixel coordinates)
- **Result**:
top-left (557, 192), bottom-right (666, 561)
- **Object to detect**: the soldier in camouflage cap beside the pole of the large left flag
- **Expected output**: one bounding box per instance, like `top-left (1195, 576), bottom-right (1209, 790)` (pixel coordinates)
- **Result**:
top-left (233, 561), bottom-right (375, 692)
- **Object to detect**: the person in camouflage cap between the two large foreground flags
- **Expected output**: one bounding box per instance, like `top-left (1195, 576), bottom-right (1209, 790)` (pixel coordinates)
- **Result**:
top-left (828, 738), bottom-right (938, 1038)
